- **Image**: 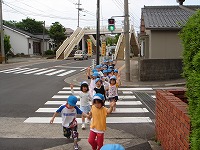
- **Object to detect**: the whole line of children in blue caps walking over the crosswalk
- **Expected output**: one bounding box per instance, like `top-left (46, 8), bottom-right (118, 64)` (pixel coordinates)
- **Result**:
top-left (50, 60), bottom-right (121, 150)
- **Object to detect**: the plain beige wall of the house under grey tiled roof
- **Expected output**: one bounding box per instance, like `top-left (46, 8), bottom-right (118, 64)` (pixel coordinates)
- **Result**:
top-left (149, 30), bottom-right (183, 59)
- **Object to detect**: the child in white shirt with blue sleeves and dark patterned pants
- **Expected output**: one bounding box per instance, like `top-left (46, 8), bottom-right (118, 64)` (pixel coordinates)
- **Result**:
top-left (50, 95), bottom-right (90, 150)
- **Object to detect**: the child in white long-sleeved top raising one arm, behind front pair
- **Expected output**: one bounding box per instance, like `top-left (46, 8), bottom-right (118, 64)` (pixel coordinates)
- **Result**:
top-left (70, 81), bottom-right (92, 130)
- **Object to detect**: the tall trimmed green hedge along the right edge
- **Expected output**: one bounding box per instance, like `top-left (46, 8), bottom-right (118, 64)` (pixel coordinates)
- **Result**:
top-left (180, 10), bottom-right (200, 150)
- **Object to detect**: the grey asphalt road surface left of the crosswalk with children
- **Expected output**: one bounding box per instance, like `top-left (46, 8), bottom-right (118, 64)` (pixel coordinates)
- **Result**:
top-left (0, 60), bottom-right (91, 117)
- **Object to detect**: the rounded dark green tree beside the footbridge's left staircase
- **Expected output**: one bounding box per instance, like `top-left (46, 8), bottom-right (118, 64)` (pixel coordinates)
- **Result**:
top-left (49, 22), bottom-right (66, 47)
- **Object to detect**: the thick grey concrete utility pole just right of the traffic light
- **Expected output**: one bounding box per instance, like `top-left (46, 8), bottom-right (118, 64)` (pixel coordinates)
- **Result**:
top-left (124, 0), bottom-right (130, 81)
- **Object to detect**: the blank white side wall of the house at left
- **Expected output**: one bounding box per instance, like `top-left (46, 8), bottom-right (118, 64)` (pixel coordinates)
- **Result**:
top-left (4, 28), bottom-right (28, 55)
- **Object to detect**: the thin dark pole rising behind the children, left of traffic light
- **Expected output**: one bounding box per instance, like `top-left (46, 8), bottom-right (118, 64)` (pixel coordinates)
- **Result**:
top-left (96, 0), bottom-right (100, 65)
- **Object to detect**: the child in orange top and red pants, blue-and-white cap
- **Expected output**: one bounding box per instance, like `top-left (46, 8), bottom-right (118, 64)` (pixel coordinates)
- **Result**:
top-left (88, 93), bottom-right (115, 150)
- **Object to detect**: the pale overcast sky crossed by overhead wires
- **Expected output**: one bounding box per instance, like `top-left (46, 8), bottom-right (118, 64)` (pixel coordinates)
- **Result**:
top-left (3, 0), bottom-right (200, 30)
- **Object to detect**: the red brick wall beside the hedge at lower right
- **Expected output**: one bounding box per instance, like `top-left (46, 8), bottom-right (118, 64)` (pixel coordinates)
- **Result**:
top-left (156, 90), bottom-right (190, 150)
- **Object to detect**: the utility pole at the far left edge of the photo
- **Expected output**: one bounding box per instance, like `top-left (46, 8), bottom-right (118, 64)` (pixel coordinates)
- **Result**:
top-left (0, 0), bottom-right (5, 64)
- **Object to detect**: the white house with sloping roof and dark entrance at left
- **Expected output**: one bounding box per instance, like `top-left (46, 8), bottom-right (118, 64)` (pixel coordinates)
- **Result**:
top-left (3, 25), bottom-right (54, 55)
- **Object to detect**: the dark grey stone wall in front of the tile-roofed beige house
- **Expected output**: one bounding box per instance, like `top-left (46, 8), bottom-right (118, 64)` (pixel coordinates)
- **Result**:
top-left (139, 59), bottom-right (183, 81)
